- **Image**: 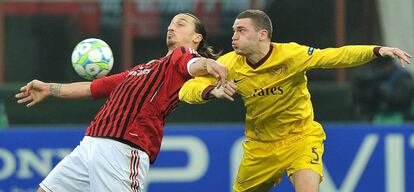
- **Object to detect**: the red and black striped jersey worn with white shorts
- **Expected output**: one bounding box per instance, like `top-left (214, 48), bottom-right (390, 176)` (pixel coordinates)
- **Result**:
top-left (86, 47), bottom-right (200, 163)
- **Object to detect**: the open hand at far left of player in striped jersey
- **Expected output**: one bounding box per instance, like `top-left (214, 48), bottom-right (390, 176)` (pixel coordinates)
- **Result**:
top-left (15, 80), bottom-right (50, 107)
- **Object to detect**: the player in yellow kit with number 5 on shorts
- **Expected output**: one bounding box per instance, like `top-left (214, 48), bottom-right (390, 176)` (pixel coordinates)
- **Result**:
top-left (179, 10), bottom-right (411, 192)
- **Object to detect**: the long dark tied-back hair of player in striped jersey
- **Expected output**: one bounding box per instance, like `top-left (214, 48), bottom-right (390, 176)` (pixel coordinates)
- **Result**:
top-left (184, 13), bottom-right (221, 59)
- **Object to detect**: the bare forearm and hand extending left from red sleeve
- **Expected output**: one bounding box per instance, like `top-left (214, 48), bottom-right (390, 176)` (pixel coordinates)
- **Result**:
top-left (15, 80), bottom-right (92, 107)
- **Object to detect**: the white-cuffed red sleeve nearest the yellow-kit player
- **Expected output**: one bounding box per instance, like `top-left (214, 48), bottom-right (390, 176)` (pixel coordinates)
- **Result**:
top-left (171, 47), bottom-right (201, 79)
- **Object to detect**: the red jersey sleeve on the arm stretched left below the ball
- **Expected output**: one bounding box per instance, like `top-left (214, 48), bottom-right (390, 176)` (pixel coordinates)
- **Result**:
top-left (90, 71), bottom-right (129, 99)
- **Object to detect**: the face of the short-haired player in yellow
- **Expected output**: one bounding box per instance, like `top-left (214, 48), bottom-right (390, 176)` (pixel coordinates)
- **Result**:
top-left (231, 18), bottom-right (259, 56)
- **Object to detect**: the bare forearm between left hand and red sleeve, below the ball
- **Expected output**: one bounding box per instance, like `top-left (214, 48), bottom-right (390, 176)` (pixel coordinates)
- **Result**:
top-left (49, 82), bottom-right (92, 99)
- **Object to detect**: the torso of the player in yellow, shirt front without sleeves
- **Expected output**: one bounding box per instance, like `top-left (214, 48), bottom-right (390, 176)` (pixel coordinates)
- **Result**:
top-left (222, 43), bottom-right (313, 140)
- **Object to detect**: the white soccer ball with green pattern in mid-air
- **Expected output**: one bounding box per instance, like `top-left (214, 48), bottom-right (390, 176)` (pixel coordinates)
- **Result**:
top-left (72, 38), bottom-right (114, 80)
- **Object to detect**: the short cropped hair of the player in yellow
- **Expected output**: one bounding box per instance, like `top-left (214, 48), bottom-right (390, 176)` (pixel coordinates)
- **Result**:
top-left (236, 10), bottom-right (273, 39)
